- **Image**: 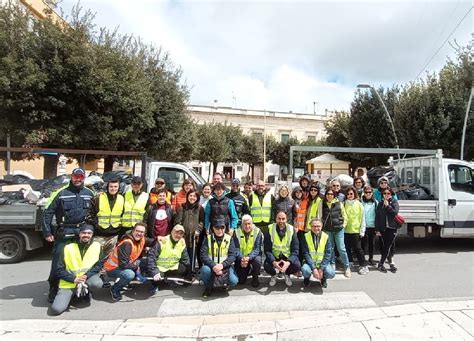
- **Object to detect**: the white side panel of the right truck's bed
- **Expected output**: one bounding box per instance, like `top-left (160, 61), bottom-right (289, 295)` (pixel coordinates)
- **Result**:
top-left (399, 200), bottom-right (439, 224)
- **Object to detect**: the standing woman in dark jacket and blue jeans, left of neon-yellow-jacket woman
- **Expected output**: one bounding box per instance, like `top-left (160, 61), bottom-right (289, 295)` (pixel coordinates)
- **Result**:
top-left (322, 187), bottom-right (351, 278)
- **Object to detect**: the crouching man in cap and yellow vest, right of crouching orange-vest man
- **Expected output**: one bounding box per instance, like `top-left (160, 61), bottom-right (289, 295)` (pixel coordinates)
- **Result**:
top-left (142, 225), bottom-right (191, 295)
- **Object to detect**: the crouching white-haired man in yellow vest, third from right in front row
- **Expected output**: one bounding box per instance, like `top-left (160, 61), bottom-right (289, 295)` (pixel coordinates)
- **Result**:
top-left (234, 214), bottom-right (263, 288)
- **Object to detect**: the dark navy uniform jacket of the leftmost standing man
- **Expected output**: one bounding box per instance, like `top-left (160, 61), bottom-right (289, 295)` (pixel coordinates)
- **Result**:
top-left (42, 182), bottom-right (94, 238)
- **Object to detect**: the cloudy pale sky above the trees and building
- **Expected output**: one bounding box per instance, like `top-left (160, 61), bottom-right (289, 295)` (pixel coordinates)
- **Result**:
top-left (60, 0), bottom-right (474, 114)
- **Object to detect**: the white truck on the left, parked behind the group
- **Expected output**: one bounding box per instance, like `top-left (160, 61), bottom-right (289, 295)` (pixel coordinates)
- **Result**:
top-left (0, 161), bottom-right (205, 264)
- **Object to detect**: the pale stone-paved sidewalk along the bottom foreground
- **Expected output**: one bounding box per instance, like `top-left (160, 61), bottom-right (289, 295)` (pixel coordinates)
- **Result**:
top-left (0, 299), bottom-right (474, 341)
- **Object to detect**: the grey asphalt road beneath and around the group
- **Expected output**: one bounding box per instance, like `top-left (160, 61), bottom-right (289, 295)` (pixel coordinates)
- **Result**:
top-left (0, 238), bottom-right (474, 320)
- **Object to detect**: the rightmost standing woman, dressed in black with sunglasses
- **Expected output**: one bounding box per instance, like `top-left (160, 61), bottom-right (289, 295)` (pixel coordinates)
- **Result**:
top-left (375, 187), bottom-right (399, 272)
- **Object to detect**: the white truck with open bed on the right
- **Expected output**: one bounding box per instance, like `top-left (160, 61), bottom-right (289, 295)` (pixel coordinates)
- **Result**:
top-left (289, 146), bottom-right (474, 238)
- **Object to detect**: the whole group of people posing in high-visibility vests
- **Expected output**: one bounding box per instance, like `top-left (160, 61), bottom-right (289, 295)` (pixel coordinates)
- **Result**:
top-left (43, 168), bottom-right (398, 314)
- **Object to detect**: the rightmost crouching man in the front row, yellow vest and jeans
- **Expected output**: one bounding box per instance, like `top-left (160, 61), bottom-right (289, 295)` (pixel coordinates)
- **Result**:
top-left (301, 218), bottom-right (336, 288)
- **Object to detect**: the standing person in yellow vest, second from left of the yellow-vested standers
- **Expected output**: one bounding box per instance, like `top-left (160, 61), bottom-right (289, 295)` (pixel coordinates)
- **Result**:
top-left (121, 176), bottom-right (149, 236)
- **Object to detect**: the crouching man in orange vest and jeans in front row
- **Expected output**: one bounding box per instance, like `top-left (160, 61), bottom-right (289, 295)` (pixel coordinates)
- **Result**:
top-left (104, 222), bottom-right (155, 301)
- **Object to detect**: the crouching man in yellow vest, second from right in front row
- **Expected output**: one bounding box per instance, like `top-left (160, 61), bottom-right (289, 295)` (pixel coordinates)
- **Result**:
top-left (263, 211), bottom-right (301, 287)
